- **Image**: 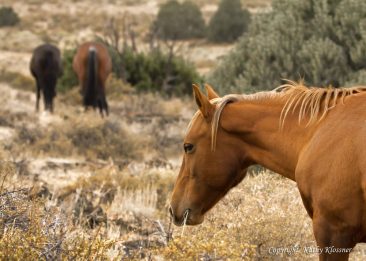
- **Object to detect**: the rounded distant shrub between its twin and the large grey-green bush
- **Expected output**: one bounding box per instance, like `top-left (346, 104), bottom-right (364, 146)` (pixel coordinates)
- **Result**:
top-left (208, 0), bottom-right (250, 42)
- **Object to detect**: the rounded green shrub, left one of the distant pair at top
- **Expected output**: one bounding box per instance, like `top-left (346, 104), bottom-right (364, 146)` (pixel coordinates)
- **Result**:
top-left (152, 0), bottom-right (205, 40)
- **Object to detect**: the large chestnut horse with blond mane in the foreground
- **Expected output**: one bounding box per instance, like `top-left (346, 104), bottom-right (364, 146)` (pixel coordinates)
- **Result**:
top-left (170, 82), bottom-right (366, 260)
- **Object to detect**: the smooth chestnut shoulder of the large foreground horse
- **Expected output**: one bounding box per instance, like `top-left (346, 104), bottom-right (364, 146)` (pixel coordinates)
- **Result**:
top-left (295, 103), bottom-right (366, 230)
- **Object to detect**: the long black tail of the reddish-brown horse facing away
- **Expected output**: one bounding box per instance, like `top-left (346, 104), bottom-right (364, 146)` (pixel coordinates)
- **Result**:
top-left (84, 46), bottom-right (98, 108)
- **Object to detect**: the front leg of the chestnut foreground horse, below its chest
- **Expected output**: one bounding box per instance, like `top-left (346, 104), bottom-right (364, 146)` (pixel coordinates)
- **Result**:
top-left (313, 217), bottom-right (357, 261)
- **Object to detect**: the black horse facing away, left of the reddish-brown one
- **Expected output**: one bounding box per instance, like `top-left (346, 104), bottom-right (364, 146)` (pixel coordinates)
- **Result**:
top-left (30, 44), bottom-right (62, 112)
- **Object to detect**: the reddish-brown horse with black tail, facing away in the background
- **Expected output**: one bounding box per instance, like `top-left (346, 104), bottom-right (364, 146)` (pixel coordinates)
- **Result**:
top-left (73, 42), bottom-right (112, 117)
